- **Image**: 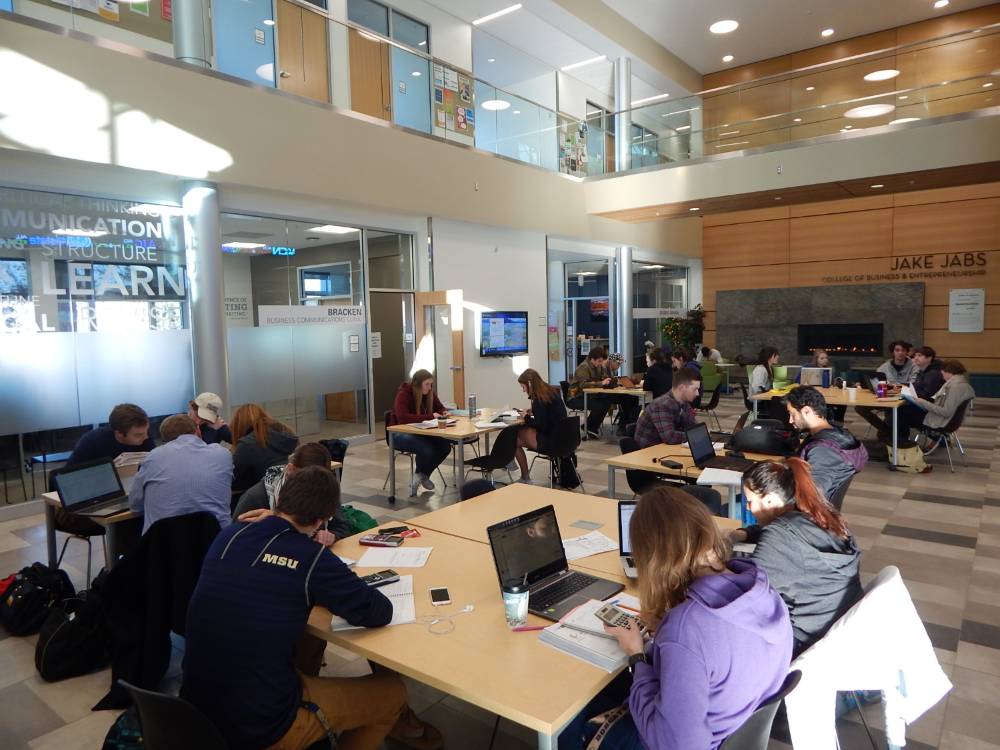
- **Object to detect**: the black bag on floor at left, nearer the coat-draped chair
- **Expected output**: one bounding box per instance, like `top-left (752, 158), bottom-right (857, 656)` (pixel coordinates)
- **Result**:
top-left (35, 584), bottom-right (111, 682)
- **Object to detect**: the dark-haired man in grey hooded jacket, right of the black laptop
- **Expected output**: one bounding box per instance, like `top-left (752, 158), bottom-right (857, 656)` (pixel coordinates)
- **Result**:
top-left (784, 385), bottom-right (868, 510)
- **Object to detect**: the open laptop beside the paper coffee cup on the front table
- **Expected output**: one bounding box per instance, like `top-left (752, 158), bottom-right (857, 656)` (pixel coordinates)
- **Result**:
top-left (486, 505), bottom-right (624, 621)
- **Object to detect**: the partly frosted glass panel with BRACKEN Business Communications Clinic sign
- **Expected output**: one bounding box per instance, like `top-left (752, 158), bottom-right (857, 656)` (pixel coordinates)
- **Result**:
top-left (221, 214), bottom-right (369, 440)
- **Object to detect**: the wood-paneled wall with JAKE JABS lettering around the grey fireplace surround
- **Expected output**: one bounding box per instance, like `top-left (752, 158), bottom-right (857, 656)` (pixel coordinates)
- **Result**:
top-left (702, 182), bottom-right (1000, 372)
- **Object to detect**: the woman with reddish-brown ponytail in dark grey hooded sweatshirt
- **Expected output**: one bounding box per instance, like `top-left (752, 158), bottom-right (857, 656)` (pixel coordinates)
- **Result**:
top-left (732, 458), bottom-right (861, 655)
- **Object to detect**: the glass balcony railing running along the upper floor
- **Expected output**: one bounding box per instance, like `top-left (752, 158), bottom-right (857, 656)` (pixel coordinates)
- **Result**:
top-left (7, 0), bottom-right (1000, 177)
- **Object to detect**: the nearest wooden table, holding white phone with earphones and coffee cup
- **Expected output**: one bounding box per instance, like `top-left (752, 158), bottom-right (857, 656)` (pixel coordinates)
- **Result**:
top-left (307, 524), bottom-right (635, 750)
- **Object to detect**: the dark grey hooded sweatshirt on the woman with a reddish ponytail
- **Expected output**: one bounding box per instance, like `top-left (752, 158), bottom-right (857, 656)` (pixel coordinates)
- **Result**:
top-left (747, 511), bottom-right (862, 656)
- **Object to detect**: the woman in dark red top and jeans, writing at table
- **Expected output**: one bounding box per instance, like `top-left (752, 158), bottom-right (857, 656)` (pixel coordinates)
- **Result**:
top-left (392, 370), bottom-right (451, 497)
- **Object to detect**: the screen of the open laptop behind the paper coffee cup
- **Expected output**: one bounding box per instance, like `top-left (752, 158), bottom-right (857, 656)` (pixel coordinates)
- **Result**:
top-left (487, 505), bottom-right (567, 585)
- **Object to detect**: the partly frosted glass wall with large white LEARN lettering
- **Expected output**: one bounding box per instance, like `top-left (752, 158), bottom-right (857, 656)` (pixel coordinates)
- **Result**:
top-left (0, 188), bottom-right (194, 435)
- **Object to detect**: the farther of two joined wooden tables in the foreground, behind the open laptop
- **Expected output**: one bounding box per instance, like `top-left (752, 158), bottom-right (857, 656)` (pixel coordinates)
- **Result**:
top-left (408, 484), bottom-right (740, 579)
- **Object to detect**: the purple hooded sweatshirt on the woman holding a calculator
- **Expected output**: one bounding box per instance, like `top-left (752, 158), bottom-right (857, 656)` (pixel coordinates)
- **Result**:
top-left (628, 560), bottom-right (792, 750)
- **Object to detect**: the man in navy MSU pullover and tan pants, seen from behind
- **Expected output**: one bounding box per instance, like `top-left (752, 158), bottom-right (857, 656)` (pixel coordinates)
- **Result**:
top-left (181, 466), bottom-right (441, 750)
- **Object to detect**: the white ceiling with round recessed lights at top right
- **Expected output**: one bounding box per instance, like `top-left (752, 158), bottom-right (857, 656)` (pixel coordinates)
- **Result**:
top-left (600, 0), bottom-right (994, 74)
